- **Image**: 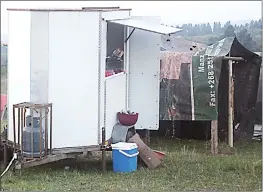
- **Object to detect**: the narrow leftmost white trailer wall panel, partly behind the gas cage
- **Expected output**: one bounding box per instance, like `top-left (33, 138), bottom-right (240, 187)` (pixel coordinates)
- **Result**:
top-left (7, 11), bottom-right (31, 142)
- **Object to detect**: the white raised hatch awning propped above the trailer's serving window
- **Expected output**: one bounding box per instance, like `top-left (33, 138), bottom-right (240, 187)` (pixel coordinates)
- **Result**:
top-left (108, 18), bottom-right (182, 35)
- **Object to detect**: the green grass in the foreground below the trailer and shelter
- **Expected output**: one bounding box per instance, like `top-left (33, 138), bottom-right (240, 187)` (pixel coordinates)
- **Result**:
top-left (3, 140), bottom-right (262, 191)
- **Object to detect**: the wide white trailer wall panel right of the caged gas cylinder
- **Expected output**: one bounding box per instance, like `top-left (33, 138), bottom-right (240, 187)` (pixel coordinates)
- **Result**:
top-left (49, 12), bottom-right (100, 148)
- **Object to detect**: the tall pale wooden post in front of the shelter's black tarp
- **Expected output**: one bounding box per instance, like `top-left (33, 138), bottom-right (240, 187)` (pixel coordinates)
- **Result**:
top-left (228, 60), bottom-right (234, 147)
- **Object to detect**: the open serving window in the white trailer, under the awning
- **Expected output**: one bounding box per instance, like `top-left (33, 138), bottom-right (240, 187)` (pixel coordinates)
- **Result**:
top-left (105, 22), bottom-right (125, 77)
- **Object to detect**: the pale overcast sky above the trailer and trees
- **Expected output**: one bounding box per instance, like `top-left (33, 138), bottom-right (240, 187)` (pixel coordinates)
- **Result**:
top-left (1, 1), bottom-right (262, 34)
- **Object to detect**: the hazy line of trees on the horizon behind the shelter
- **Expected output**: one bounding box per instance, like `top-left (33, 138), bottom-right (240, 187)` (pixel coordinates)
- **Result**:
top-left (176, 19), bottom-right (262, 52)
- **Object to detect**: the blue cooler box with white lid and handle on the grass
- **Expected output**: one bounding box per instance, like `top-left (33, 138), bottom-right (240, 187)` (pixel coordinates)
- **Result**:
top-left (111, 142), bottom-right (139, 173)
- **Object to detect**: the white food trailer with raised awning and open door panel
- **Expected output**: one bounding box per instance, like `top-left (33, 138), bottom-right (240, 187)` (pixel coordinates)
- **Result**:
top-left (8, 8), bottom-right (183, 156)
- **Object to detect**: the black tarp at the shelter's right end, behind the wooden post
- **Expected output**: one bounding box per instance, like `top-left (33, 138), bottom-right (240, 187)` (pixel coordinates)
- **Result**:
top-left (218, 38), bottom-right (262, 139)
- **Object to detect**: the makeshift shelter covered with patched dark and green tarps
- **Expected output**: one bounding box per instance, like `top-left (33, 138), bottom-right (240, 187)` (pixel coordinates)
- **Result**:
top-left (160, 37), bottom-right (262, 139)
